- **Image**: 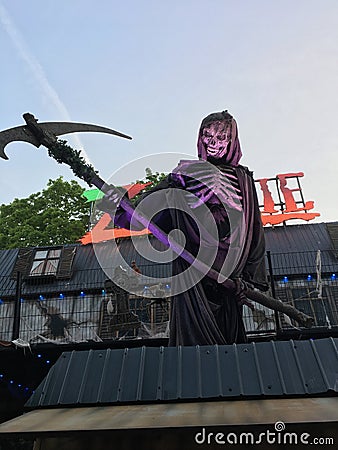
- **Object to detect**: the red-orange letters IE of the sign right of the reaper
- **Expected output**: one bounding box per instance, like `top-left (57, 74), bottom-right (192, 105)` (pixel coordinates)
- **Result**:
top-left (256, 172), bottom-right (320, 225)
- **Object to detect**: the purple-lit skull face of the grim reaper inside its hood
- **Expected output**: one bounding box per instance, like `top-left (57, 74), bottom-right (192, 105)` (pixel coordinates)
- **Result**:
top-left (202, 121), bottom-right (231, 159)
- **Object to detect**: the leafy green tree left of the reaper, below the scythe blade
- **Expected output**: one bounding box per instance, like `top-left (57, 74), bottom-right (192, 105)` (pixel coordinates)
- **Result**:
top-left (0, 177), bottom-right (89, 249)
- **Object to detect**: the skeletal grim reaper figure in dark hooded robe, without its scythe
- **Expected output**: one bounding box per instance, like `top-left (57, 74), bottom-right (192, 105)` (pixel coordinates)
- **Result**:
top-left (101, 111), bottom-right (268, 346)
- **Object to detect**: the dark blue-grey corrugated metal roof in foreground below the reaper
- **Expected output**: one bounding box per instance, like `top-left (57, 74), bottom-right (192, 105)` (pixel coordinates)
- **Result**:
top-left (27, 338), bottom-right (338, 408)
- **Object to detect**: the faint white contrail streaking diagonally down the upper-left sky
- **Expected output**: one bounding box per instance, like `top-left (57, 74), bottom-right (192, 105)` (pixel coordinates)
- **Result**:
top-left (0, 3), bottom-right (90, 162)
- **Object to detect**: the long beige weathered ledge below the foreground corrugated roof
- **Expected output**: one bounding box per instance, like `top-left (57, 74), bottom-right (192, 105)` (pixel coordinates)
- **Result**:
top-left (0, 397), bottom-right (338, 435)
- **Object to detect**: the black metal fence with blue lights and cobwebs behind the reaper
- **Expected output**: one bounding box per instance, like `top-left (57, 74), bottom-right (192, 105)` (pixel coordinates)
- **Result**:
top-left (0, 252), bottom-right (338, 344)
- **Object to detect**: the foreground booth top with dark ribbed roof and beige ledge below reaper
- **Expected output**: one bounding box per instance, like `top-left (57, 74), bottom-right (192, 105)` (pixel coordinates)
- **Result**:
top-left (0, 338), bottom-right (338, 450)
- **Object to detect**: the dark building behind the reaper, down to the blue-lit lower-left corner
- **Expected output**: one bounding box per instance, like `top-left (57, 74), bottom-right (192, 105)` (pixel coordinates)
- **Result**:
top-left (0, 223), bottom-right (338, 420)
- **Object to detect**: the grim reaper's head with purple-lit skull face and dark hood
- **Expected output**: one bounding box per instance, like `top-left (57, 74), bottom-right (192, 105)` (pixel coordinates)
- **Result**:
top-left (197, 111), bottom-right (242, 166)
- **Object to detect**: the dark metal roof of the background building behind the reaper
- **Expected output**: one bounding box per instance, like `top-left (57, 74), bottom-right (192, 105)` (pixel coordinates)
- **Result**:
top-left (0, 222), bottom-right (338, 297)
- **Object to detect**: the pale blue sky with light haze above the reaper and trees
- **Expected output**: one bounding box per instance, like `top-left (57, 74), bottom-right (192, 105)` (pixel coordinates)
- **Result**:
top-left (0, 0), bottom-right (338, 222)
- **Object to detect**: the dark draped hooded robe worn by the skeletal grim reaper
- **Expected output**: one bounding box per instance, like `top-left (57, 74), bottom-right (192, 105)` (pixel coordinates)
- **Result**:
top-left (107, 111), bottom-right (267, 346)
